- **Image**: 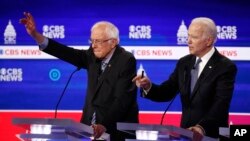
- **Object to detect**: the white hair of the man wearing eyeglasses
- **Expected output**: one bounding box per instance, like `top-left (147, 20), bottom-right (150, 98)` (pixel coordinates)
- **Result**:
top-left (91, 21), bottom-right (120, 43)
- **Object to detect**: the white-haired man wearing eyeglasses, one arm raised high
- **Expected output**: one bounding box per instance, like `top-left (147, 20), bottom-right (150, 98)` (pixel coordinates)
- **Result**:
top-left (20, 12), bottom-right (138, 141)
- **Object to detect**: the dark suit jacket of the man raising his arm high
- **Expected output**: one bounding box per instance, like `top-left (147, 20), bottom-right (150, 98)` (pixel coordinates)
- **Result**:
top-left (43, 40), bottom-right (138, 140)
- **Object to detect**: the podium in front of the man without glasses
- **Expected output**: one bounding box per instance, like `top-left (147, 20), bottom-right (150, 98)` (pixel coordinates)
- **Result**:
top-left (117, 122), bottom-right (218, 141)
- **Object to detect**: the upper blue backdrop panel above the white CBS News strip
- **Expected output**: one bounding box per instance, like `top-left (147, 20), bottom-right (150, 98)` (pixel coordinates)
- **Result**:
top-left (0, 0), bottom-right (250, 46)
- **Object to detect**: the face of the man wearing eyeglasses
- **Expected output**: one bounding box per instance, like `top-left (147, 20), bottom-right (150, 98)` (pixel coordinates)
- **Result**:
top-left (91, 27), bottom-right (116, 59)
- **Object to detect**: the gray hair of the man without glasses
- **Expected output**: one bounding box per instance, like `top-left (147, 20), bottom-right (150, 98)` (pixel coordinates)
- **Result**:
top-left (191, 17), bottom-right (217, 43)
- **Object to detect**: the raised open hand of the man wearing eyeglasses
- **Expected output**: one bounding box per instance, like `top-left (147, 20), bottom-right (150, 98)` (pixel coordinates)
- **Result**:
top-left (19, 12), bottom-right (45, 44)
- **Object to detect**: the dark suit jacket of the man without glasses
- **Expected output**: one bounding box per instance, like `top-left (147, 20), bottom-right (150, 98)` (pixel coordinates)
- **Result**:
top-left (146, 50), bottom-right (237, 137)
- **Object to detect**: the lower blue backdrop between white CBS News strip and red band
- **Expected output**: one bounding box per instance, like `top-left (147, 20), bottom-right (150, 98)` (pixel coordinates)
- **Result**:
top-left (0, 60), bottom-right (250, 112)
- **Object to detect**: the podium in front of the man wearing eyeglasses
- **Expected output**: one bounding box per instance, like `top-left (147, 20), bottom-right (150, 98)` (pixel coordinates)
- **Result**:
top-left (12, 118), bottom-right (110, 141)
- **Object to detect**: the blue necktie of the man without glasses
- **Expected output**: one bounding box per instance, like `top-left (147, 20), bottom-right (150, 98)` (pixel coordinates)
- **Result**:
top-left (190, 58), bottom-right (202, 94)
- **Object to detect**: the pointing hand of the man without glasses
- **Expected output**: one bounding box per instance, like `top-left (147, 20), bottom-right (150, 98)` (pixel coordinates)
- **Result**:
top-left (132, 75), bottom-right (151, 91)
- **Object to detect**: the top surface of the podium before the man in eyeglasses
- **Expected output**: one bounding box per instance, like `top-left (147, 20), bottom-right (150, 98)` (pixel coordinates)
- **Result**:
top-left (12, 118), bottom-right (109, 140)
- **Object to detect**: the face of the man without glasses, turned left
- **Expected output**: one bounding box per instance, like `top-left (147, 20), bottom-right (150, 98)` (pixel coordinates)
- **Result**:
top-left (188, 23), bottom-right (211, 57)
